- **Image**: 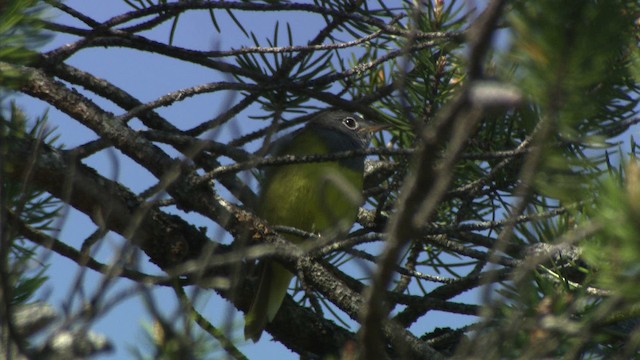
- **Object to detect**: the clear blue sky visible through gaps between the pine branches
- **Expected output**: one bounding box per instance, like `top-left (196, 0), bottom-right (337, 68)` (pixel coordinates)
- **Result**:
top-left (13, 0), bottom-right (475, 359)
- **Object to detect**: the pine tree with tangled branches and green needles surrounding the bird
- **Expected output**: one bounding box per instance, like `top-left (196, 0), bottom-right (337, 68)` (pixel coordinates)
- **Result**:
top-left (0, 0), bottom-right (640, 359)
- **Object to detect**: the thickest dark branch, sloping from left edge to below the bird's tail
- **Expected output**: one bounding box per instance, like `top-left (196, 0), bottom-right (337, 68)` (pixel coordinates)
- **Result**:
top-left (5, 137), bottom-right (353, 354)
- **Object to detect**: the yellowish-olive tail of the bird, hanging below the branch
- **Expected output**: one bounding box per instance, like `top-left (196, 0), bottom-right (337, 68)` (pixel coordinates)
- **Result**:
top-left (244, 261), bottom-right (293, 342)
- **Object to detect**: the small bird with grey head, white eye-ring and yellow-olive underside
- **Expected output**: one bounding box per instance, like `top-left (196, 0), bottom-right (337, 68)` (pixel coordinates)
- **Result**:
top-left (244, 110), bottom-right (386, 342)
